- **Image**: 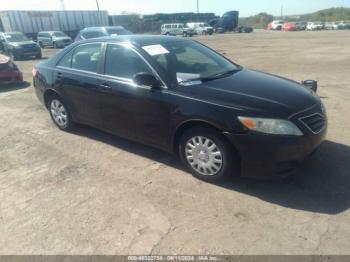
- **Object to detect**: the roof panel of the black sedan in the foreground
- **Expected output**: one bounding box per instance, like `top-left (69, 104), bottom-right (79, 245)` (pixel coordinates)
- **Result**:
top-left (78, 35), bottom-right (191, 46)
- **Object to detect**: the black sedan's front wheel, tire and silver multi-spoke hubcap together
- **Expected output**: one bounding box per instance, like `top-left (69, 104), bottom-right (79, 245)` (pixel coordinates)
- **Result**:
top-left (179, 127), bottom-right (239, 182)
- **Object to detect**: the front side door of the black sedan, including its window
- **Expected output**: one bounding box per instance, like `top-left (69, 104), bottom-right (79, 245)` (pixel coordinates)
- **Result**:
top-left (101, 44), bottom-right (170, 147)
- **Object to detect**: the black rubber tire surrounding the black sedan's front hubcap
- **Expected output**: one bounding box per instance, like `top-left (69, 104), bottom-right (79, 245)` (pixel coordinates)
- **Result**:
top-left (178, 126), bottom-right (239, 182)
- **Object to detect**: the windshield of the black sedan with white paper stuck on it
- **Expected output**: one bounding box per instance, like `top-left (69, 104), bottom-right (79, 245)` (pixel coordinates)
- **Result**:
top-left (149, 41), bottom-right (242, 85)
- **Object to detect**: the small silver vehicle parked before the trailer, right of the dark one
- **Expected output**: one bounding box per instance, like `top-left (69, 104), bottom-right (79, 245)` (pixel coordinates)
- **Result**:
top-left (37, 31), bottom-right (73, 48)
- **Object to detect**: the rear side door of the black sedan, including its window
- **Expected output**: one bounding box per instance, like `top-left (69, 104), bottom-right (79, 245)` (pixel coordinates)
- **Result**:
top-left (54, 43), bottom-right (102, 127)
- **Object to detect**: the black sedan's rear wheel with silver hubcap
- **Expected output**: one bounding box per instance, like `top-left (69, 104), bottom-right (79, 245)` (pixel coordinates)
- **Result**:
top-left (48, 95), bottom-right (75, 131)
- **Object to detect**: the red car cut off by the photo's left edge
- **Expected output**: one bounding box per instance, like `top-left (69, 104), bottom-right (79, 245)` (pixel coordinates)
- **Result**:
top-left (0, 54), bottom-right (23, 87)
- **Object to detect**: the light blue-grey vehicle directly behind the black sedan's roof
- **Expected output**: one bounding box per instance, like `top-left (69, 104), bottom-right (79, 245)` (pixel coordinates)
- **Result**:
top-left (74, 26), bottom-right (132, 42)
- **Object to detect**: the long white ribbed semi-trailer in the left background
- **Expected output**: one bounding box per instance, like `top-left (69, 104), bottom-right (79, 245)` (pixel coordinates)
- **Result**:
top-left (0, 11), bottom-right (108, 38)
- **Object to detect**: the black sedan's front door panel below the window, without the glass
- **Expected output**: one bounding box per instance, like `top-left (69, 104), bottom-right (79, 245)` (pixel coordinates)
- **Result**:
top-left (100, 77), bottom-right (170, 147)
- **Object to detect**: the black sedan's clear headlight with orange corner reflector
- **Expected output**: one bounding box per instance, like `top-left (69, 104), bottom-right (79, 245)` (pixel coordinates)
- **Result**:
top-left (238, 116), bottom-right (303, 136)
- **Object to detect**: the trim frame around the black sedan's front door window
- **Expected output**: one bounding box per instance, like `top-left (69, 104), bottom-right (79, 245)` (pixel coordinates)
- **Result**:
top-left (102, 43), bottom-right (168, 89)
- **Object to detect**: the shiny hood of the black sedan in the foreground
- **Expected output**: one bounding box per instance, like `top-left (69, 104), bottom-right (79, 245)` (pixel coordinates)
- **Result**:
top-left (180, 69), bottom-right (320, 118)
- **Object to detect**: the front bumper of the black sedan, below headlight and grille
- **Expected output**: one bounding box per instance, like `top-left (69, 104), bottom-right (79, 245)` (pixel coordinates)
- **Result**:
top-left (225, 128), bottom-right (327, 179)
